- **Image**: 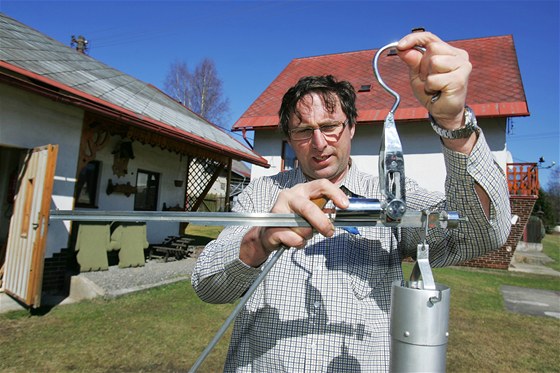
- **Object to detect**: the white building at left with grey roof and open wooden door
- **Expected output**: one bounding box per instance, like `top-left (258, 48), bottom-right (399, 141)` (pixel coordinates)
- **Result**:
top-left (0, 14), bottom-right (267, 306)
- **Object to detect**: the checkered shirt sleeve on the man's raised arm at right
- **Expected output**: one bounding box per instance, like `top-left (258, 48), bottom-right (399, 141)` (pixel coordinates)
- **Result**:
top-left (401, 131), bottom-right (511, 267)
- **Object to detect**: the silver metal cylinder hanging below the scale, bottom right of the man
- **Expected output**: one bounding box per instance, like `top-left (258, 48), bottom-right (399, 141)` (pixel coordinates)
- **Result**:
top-left (390, 281), bottom-right (450, 372)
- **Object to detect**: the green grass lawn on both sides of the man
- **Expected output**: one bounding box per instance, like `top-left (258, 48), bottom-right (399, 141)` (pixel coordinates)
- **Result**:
top-left (0, 232), bottom-right (560, 372)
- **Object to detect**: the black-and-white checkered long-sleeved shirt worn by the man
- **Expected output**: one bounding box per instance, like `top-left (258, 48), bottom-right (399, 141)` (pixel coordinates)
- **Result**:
top-left (192, 133), bottom-right (510, 373)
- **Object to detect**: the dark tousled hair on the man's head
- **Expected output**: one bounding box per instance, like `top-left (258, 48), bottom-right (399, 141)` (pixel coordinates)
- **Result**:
top-left (278, 75), bottom-right (358, 136)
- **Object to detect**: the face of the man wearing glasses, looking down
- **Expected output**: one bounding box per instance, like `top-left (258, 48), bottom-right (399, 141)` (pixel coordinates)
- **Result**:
top-left (288, 93), bottom-right (355, 184)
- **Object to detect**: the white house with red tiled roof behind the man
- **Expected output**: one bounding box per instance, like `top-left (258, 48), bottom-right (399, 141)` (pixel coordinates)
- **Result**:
top-left (234, 35), bottom-right (529, 191)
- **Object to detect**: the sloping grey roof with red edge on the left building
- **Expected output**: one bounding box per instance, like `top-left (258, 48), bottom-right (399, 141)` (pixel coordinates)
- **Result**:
top-left (0, 13), bottom-right (268, 166)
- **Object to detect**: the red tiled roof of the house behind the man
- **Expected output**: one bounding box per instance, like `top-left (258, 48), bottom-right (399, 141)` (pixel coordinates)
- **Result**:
top-left (233, 35), bottom-right (529, 130)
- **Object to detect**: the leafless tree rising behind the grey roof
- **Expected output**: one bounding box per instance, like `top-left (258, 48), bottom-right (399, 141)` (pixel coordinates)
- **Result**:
top-left (164, 58), bottom-right (229, 129)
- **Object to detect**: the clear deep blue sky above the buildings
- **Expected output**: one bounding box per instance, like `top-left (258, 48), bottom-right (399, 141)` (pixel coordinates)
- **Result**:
top-left (0, 0), bottom-right (560, 187)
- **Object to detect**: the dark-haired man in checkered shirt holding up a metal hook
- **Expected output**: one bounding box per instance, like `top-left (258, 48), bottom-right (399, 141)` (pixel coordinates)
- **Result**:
top-left (192, 32), bottom-right (510, 372)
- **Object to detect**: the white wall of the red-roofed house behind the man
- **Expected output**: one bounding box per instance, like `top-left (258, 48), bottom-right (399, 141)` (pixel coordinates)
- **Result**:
top-left (251, 118), bottom-right (511, 192)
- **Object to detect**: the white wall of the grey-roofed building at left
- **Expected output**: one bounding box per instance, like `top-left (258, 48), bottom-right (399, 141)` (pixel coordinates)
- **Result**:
top-left (0, 84), bottom-right (201, 258)
